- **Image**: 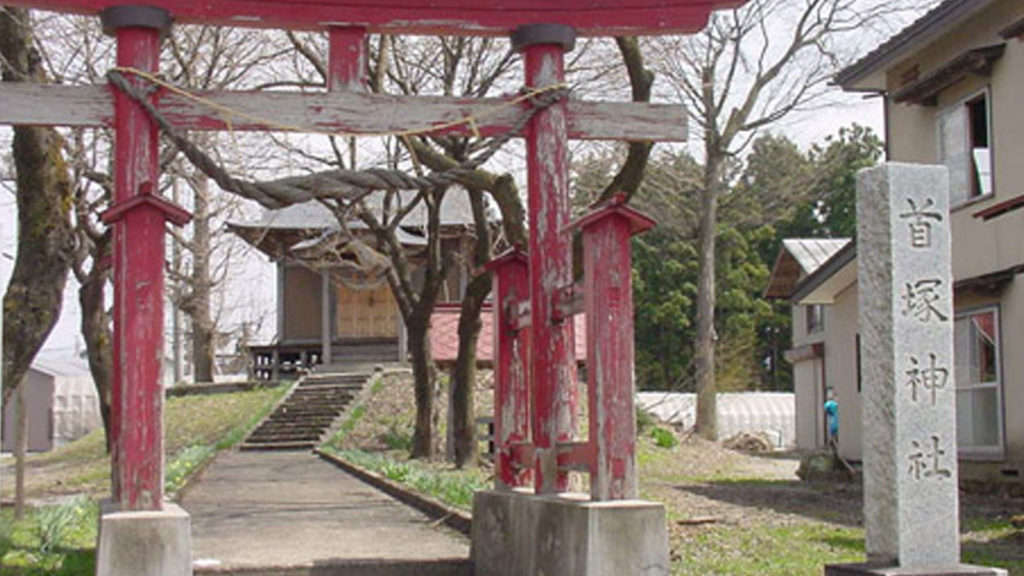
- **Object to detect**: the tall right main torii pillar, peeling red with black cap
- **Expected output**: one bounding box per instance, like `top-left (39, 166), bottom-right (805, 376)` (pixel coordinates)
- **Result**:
top-left (512, 25), bottom-right (578, 487)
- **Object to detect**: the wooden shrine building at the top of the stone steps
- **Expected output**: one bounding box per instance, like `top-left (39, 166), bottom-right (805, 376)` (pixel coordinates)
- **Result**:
top-left (228, 188), bottom-right (497, 377)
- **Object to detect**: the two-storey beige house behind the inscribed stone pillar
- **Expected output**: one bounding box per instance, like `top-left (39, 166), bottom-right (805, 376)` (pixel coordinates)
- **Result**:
top-left (766, 0), bottom-right (1024, 483)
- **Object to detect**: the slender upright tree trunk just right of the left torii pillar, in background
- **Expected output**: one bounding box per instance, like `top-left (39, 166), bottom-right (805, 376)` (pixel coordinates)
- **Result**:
top-left (189, 174), bottom-right (214, 382)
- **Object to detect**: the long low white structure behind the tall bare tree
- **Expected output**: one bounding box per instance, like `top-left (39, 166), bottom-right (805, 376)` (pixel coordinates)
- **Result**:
top-left (637, 392), bottom-right (796, 449)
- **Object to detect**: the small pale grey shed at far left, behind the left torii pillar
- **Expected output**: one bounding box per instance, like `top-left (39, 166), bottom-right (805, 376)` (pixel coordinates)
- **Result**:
top-left (3, 359), bottom-right (102, 452)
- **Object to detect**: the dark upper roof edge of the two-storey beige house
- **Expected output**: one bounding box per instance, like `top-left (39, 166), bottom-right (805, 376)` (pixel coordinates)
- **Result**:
top-left (836, 0), bottom-right (997, 90)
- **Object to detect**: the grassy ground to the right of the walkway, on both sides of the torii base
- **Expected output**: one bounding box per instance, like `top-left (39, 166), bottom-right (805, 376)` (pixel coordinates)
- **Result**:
top-left (326, 373), bottom-right (1024, 576)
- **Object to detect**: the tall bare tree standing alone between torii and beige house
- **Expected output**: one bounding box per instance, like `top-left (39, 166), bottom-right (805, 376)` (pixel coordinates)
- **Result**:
top-left (653, 0), bottom-right (912, 439)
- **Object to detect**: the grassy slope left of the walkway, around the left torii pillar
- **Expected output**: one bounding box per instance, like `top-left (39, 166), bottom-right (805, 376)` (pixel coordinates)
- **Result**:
top-left (0, 386), bottom-right (288, 576)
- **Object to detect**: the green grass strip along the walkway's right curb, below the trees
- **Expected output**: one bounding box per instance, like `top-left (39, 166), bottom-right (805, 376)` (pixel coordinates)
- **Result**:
top-left (328, 449), bottom-right (492, 511)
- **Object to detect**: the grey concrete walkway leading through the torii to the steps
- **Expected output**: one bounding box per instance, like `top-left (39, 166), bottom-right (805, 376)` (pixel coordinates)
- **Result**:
top-left (181, 452), bottom-right (471, 576)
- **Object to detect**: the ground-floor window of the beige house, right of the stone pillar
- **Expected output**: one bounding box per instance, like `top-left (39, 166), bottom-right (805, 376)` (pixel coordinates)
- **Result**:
top-left (953, 307), bottom-right (1002, 456)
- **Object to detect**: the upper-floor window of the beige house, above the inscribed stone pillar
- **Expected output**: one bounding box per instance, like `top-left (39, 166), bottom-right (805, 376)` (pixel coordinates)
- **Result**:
top-left (938, 92), bottom-right (992, 206)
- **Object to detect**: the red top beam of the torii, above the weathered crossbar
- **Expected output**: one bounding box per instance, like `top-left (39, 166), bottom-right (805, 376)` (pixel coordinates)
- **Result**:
top-left (4, 0), bottom-right (742, 36)
